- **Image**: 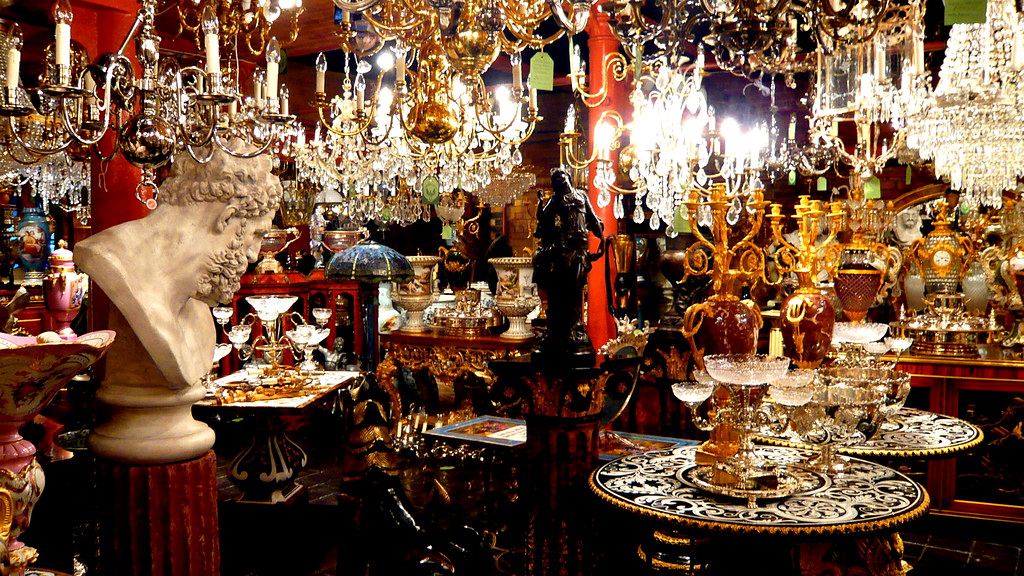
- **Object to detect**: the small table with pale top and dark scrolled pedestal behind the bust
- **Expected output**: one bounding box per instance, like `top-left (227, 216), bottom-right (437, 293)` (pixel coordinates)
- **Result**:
top-left (196, 370), bottom-right (359, 504)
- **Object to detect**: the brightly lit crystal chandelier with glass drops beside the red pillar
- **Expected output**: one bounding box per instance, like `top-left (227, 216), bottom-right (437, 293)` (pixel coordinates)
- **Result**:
top-left (581, 56), bottom-right (767, 237)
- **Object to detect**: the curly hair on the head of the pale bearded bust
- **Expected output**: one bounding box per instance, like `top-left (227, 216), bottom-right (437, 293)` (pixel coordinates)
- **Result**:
top-left (154, 142), bottom-right (283, 218)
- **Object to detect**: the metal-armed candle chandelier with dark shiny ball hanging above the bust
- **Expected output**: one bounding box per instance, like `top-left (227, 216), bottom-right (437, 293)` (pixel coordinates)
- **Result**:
top-left (0, 0), bottom-right (299, 207)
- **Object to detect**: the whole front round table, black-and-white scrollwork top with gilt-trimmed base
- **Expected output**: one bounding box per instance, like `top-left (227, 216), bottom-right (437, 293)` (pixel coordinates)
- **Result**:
top-left (589, 446), bottom-right (929, 575)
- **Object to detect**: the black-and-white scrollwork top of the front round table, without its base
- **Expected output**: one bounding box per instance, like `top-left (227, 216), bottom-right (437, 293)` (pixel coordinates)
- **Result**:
top-left (590, 446), bottom-right (929, 534)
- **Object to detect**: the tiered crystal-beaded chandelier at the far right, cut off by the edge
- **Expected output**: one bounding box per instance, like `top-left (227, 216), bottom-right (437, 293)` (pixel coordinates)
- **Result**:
top-left (906, 0), bottom-right (1024, 207)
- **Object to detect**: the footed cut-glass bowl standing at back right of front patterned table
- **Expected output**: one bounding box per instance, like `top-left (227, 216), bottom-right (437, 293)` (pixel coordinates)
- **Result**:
top-left (790, 383), bottom-right (883, 475)
